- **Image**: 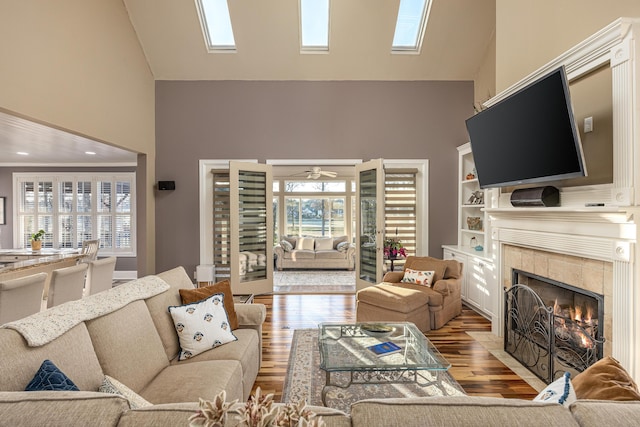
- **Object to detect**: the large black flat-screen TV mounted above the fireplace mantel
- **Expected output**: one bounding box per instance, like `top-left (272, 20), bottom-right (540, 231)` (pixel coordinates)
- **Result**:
top-left (466, 67), bottom-right (586, 188)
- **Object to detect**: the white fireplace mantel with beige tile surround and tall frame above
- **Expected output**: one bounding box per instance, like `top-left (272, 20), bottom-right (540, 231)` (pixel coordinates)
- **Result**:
top-left (485, 18), bottom-right (640, 381)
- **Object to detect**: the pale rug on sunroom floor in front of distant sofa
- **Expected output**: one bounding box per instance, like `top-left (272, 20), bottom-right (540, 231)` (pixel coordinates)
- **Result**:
top-left (273, 270), bottom-right (356, 293)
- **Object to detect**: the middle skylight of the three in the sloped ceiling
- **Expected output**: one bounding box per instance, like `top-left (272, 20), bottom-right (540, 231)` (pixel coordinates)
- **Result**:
top-left (300, 0), bottom-right (329, 51)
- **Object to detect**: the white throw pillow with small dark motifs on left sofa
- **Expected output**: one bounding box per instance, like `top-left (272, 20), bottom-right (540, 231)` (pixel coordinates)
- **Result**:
top-left (169, 294), bottom-right (238, 360)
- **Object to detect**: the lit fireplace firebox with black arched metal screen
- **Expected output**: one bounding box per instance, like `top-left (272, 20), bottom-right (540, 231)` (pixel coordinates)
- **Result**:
top-left (504, 269), bottom-right (604, 384)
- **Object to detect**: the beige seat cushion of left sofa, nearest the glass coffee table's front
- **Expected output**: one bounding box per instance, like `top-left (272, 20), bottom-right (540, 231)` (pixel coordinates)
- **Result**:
top-left (138, 360), bottom-right (243, 404)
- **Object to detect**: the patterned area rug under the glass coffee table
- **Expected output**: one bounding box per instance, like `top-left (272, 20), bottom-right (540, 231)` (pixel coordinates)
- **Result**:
top-left (282, 329), bottom-right (465, 413)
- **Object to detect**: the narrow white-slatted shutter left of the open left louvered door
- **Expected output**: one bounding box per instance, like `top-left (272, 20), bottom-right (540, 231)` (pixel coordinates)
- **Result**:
top-left (211, 169), bottom-right (231, 282)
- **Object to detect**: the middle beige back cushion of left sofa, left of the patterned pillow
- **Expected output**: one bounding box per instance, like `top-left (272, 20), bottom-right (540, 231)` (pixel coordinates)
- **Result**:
top-left (86, 300), bottom-right (169, 394)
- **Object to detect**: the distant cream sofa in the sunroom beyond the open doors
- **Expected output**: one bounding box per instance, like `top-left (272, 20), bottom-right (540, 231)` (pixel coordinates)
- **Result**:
top-left (273, 236), bottom-right (356, 270)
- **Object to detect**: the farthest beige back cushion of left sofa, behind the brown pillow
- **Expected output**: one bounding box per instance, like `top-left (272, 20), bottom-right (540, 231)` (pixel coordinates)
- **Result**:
top-left (145, 267), bottom-right (193, 360)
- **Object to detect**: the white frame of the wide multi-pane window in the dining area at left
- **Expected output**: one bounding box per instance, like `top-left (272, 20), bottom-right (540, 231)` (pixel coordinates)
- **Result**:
top-left (13, 172), bottom-right (136, 257)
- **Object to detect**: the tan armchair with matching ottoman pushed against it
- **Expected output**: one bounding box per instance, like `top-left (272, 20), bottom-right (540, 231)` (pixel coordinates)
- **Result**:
top-left (356, 256), bottom-right (463, 332)
